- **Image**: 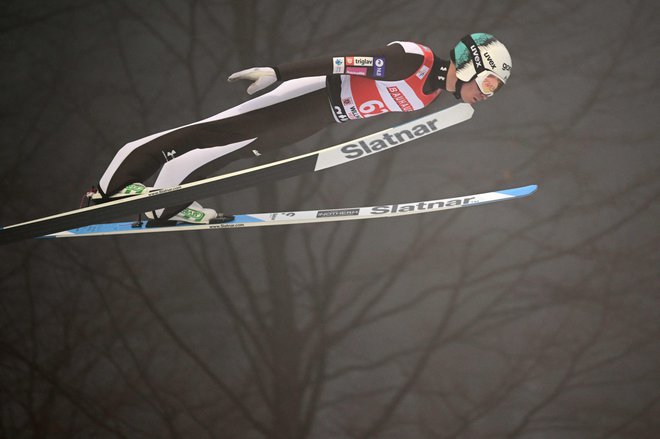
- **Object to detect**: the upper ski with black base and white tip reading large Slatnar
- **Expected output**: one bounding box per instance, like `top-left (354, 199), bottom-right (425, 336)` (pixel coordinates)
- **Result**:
top-left (0, 103), bottom-right (474, 248)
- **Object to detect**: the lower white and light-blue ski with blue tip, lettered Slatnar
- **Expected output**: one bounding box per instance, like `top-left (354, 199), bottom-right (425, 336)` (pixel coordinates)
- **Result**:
top-left (43, 185), bottom-right (537, 238)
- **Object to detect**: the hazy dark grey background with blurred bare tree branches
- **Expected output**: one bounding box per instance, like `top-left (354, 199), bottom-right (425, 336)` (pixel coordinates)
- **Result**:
top-left (0, 0), bottom-right (660, 439)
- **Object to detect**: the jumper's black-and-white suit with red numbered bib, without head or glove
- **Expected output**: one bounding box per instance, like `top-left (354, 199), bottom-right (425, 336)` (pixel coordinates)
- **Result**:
top-left (99, 42), bottom-right (449, 218)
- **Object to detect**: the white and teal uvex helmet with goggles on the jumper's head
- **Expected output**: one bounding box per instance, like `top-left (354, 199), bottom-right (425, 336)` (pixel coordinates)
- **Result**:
top-left (450, 33), bottom-right (512, 99)
